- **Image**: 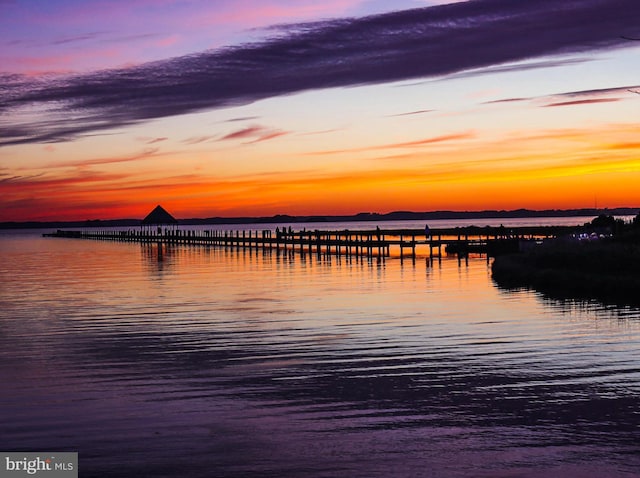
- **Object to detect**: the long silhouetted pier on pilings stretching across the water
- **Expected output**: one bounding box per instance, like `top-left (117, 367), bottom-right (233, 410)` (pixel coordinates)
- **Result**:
top-left (44, 228), bottom-right (553, 258)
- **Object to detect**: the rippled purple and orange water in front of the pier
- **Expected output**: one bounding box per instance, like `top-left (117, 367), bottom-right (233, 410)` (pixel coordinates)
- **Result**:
top-left (0, 221), bottom-right (640, 477)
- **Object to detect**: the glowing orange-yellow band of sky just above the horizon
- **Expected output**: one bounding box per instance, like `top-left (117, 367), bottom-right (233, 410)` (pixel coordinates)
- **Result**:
top-left (2, 113), bottom-right (640, 220)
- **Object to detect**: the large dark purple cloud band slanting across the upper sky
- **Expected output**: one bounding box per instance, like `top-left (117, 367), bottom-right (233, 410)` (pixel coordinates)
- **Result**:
top-left (0, 0), bottom-right (640, 146)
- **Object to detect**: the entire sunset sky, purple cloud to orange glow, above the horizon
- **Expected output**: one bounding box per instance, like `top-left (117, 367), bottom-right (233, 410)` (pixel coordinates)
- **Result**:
top-left (0, 0), bottom-right (640, 221)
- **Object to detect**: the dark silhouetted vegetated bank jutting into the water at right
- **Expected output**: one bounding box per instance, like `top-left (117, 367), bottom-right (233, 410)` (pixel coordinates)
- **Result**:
top-left (491, 214), bottom-right (640, 306)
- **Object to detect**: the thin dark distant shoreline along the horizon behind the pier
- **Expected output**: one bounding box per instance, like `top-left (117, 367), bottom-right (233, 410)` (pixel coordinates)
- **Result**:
top-left (0, 207), bottom-right (640, 229)
